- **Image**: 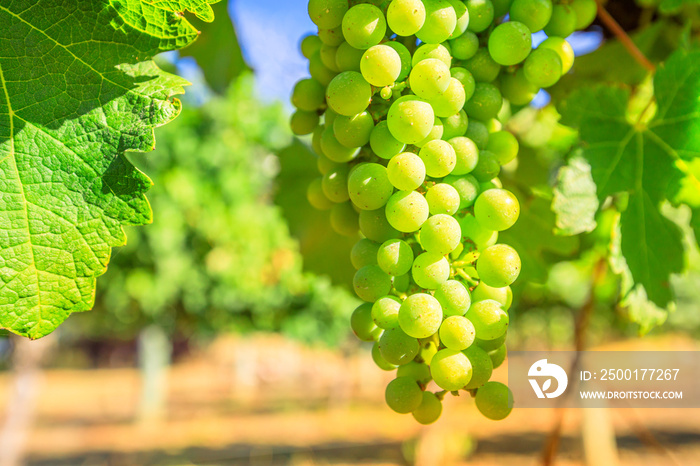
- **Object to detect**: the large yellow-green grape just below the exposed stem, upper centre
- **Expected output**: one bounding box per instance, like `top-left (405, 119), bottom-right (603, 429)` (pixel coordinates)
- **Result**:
top-left (386, 95), bottom-right (434, 144)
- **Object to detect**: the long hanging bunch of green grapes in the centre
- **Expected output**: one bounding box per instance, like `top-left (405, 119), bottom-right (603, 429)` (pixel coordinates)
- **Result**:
top-left (291, 0), bottom-right (596, 424)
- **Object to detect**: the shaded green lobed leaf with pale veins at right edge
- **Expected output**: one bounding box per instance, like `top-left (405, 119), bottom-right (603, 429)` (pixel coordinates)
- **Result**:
top-left (561, 51), bottom-right (700, 307)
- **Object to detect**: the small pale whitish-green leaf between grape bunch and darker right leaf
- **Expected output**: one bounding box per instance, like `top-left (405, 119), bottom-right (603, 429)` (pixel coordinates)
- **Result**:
top-left (552, 154), bottom-right (599, 236)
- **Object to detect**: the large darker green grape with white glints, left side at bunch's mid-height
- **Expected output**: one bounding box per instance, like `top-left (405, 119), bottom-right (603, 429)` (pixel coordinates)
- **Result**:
top-left (348, 163), bottom-right (394, 210)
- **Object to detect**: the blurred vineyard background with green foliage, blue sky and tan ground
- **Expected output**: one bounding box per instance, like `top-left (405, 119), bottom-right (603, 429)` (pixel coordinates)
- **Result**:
top-left (0, 0), bottom-right (700, 466)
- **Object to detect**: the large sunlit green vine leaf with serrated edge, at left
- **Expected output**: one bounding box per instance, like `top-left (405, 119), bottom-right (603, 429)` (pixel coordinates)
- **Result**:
top-left (0, 0), bottom-right (213, 338)
